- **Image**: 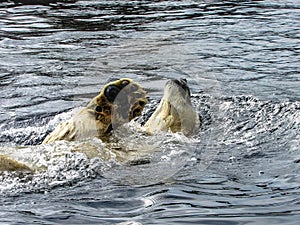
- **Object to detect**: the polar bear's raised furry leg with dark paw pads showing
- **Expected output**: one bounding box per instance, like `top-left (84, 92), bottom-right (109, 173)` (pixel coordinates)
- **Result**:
top-left (43, 78), bottom-right (147, 144)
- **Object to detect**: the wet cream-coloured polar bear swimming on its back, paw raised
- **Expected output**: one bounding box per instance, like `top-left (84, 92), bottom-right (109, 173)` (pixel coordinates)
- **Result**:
top-left (0, 78), bottom-right (200, 172)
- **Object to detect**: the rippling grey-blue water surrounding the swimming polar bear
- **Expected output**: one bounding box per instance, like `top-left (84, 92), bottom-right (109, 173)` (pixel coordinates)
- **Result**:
top-left (0, 0), bottom-right (300, 224)
